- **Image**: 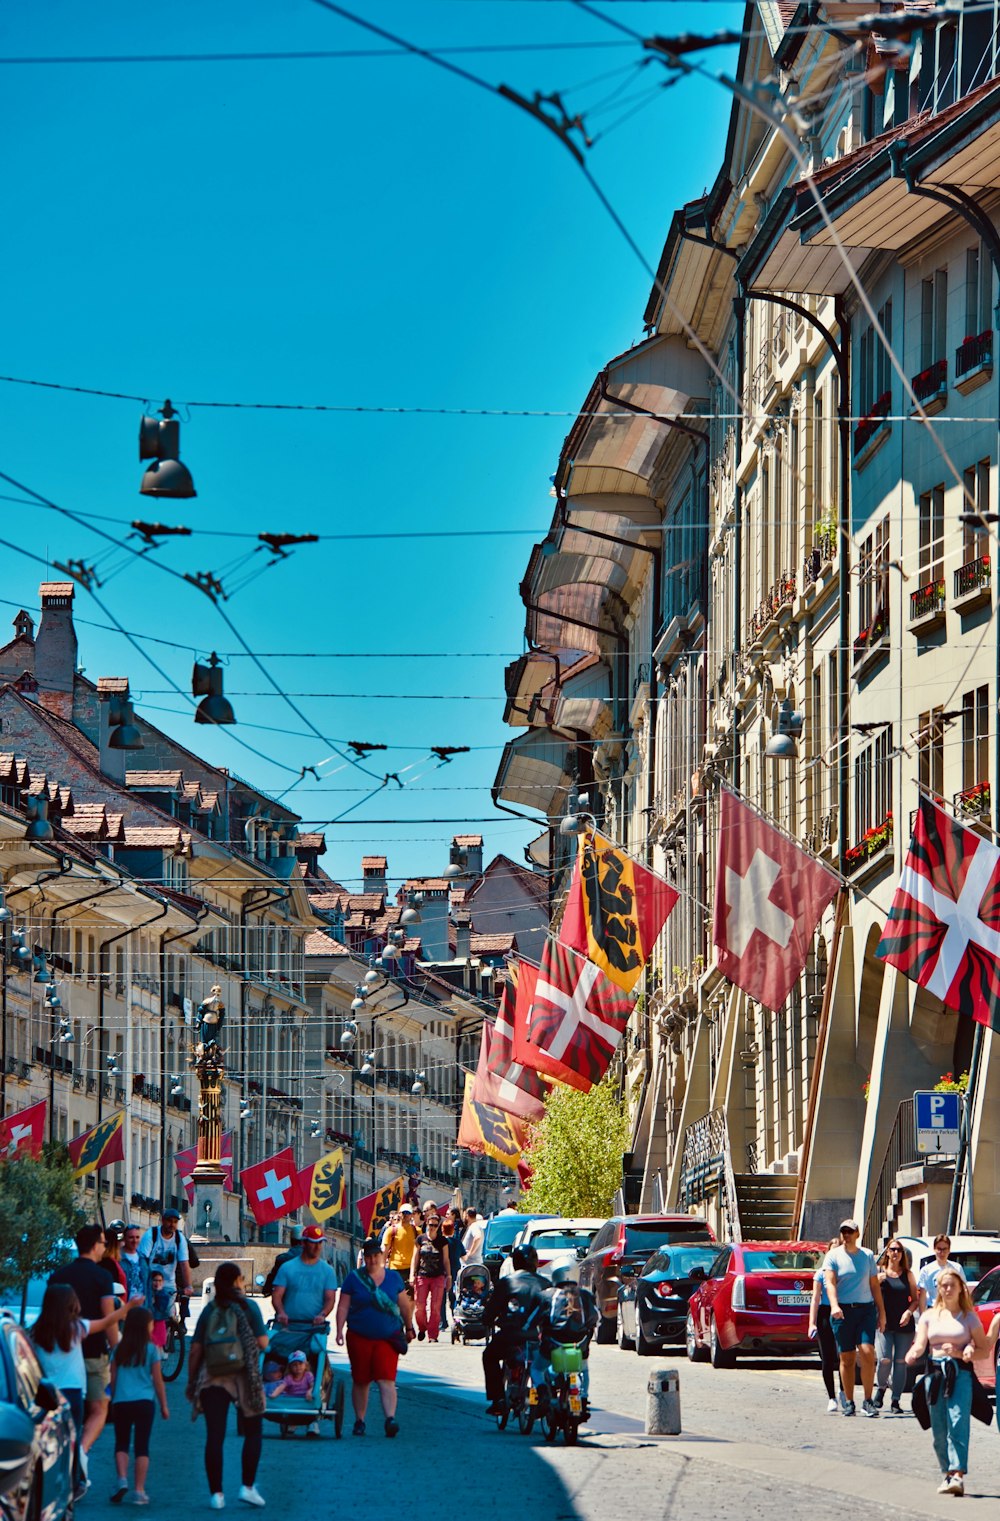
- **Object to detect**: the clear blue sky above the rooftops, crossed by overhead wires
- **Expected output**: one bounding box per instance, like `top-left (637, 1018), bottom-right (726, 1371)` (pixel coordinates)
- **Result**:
top-left (0, 0), bottom-right (741, 884)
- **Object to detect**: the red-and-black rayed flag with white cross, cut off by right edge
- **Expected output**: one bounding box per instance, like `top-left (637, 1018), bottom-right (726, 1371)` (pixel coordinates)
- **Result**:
top-left (875, 797), bottom-right (1000, 1030)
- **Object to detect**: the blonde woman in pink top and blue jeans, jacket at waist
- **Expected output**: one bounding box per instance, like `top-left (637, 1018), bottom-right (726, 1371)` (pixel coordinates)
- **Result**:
top-left (906, 1265), bottom-right (997, 1495)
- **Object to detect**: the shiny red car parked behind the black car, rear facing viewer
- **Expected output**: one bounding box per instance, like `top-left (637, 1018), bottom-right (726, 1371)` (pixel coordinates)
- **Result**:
top-left (685, 1241), bottom-right (828, 1367)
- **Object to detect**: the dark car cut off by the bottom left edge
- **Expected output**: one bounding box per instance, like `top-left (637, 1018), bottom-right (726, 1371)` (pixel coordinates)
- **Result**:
top-left (0, 1320), bottom-right (75, 1521)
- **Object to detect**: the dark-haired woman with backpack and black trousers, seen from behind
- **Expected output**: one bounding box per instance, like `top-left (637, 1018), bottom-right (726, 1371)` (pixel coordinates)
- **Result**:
top-left (187, 1262), bottom-right (268, 1510)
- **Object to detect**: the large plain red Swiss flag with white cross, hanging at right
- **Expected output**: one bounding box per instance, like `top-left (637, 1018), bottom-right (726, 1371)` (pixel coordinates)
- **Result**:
top-left (712, 788), bottom-right (840, 1013)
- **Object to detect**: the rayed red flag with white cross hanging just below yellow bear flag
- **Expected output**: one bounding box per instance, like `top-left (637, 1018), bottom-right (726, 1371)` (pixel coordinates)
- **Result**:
top-left (514, 940), bottom-right (632, 1094)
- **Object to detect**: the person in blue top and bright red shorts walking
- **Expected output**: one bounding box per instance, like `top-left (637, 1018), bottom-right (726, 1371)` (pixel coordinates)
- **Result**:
top-left (336, 1237), bottom-right (416, 1436)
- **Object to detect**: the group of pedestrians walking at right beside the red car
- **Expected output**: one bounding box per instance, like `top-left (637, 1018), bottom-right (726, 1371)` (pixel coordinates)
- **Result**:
top-left (810, 1220), bottom-right (1000, 1495)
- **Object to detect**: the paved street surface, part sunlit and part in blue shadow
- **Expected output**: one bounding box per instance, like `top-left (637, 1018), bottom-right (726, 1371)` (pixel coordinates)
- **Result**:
top-left (81, 1307), bottom-right (1000, 1521)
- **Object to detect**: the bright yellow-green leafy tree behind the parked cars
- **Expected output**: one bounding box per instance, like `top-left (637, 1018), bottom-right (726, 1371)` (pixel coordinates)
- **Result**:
top-left (521, 1077), bottom-right (629, 1215)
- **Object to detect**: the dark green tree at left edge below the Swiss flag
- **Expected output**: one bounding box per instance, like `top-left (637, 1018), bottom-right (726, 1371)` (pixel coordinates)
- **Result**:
top-left (0, 1144), bottom-right (85, 1294)
